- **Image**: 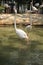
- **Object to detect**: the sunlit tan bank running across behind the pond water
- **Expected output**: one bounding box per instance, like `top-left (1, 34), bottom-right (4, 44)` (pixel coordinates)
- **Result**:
top-left (0, 13), bottom-right (43, 25)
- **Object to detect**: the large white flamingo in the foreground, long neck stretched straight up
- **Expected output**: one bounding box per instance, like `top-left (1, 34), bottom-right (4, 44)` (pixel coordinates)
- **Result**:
top-left (14, 8), bottom-right (28, 40)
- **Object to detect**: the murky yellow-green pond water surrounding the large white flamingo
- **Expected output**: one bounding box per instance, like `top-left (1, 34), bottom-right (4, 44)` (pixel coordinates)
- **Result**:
top-left (0, 26), bottom-right (43, 65)
